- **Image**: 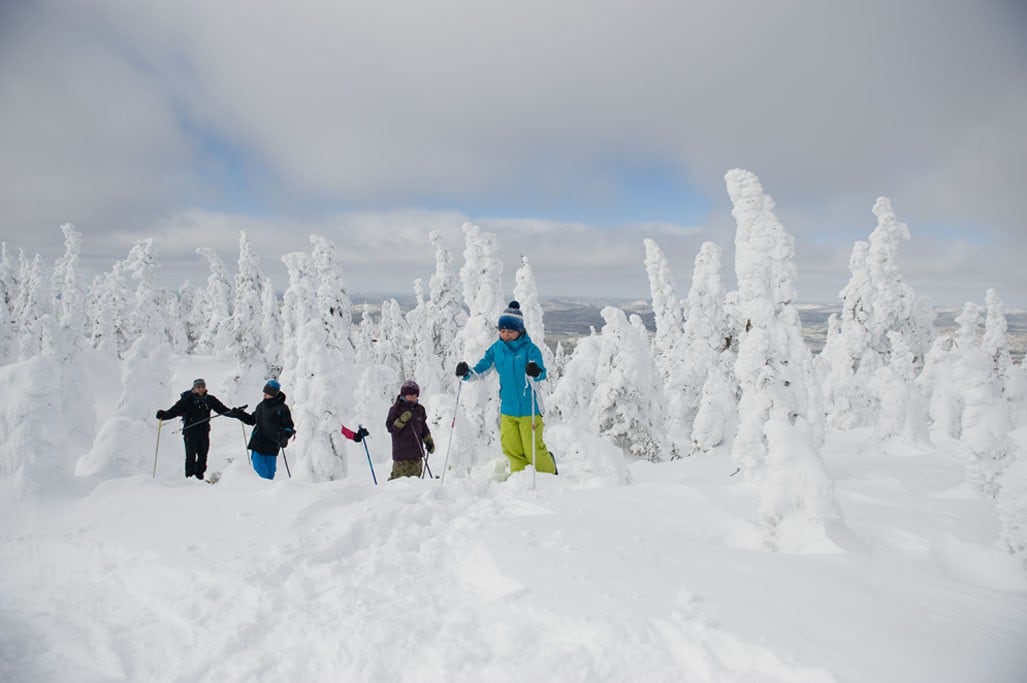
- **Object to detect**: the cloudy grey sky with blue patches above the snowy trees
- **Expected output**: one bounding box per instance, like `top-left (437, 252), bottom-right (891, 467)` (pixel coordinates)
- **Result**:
top-left (0, 0), bottom-right (1027, 307)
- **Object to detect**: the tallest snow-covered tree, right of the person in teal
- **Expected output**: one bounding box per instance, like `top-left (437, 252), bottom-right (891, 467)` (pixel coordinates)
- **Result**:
top-left (725, 169), bottom-right (841, 549)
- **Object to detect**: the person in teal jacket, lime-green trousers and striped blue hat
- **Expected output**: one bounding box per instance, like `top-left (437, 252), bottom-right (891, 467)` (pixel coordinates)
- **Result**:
top-left (456, 301), bottom-right (557, 475)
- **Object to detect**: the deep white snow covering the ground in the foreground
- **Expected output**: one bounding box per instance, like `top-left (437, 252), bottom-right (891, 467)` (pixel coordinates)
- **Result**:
top-left (6, 421), bottom-right (1027, 683)
